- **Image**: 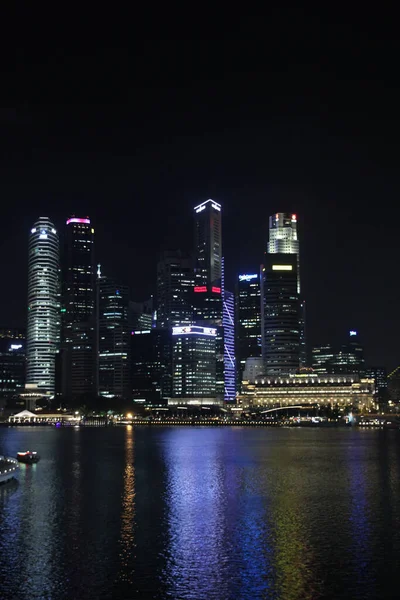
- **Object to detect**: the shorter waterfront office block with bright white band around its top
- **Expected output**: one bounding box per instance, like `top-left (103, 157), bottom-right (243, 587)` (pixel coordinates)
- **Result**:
top-left (169, 325), bottom-right (218, 405)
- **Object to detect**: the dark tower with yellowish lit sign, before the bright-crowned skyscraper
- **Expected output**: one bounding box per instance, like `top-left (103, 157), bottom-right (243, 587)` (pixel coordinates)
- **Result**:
top-left (261, 254), bottom-right (300, 374)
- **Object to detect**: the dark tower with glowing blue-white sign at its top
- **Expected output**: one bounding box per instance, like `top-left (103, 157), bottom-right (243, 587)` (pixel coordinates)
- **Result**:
top-left (236, 273), bottom-right (261, 384)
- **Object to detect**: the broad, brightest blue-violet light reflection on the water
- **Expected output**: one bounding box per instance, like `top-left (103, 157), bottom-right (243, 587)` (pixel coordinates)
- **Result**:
top-left (166, 429), bottom-right (230, 598)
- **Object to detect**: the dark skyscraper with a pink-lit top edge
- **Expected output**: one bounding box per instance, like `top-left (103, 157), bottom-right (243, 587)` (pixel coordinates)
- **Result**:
top-left (61, 216), bottom-right (97, 397)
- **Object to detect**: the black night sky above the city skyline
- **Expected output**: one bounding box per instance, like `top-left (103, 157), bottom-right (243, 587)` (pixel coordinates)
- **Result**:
top-left (0, 5), bottom-right (400, 369)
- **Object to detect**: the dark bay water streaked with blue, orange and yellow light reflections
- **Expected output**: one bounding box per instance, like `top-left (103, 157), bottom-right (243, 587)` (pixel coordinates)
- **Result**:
top-left (0, 427), bottom-right (400, 600)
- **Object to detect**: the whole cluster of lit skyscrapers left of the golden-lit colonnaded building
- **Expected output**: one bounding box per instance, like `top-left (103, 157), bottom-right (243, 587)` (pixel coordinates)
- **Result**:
top-left (26, 204), bottom-right (306, 404)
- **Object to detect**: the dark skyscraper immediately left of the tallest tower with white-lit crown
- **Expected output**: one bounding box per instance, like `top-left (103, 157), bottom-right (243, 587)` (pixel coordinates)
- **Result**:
top-left (157, 251), bottom-right (194, 329)
